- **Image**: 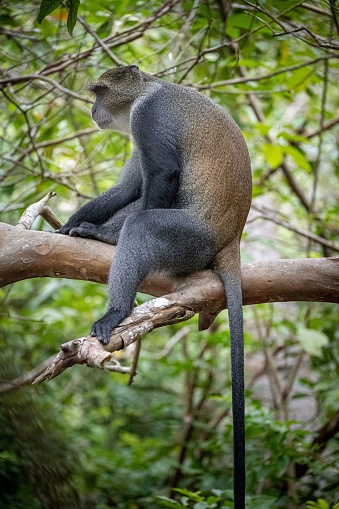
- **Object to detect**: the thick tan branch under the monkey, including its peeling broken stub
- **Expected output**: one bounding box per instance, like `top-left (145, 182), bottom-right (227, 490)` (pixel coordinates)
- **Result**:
top-left (0, 223), bottom-right (339, 382)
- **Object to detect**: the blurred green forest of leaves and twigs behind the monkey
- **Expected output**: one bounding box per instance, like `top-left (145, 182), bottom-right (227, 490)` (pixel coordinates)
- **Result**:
top-left (0, 0), bottom-right (339, 509)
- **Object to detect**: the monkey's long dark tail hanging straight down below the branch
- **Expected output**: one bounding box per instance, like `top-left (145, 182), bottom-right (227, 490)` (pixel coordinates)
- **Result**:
top-left (215, 257), bottom-right (246, 509)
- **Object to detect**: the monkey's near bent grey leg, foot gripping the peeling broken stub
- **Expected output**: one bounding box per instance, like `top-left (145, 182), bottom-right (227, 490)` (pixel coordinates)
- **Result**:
top-left (91, 209), bottom-right (215, 344)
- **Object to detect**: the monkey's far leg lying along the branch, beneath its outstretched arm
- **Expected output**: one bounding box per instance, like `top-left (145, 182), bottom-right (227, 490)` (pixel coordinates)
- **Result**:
top-left (69, 199), bottom-right (141, 245)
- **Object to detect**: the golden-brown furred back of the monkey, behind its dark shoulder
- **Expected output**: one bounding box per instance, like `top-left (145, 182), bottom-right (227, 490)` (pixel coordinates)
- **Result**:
top-left (167, 85), bottom-right (252, 247)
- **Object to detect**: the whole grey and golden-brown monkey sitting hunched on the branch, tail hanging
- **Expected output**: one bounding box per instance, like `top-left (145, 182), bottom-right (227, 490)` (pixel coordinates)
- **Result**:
top-left (59, 65), bottom-right (252, 509)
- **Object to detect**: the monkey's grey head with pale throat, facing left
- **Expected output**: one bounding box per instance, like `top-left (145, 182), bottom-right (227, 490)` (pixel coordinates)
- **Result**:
top-left (87, 65), bottom-right (152, 132)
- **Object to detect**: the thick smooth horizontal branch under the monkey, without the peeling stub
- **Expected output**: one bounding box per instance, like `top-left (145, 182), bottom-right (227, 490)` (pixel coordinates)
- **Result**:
top-left (0, 218), bottom-right (339, 306)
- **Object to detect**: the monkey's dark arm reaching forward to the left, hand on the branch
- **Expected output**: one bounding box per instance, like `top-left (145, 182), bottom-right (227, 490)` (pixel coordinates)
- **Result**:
top-left (59, 150), bottom-right (142, 235)
